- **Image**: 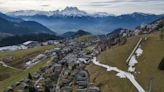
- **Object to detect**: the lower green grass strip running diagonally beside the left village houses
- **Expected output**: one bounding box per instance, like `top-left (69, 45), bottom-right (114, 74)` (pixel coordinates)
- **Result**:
top-left (0, 58), bottom-right (51, 92)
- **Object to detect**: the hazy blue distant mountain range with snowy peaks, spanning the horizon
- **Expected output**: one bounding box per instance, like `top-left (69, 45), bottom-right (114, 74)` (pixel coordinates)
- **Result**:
top-left (7, 7), bottom-right (164, 34)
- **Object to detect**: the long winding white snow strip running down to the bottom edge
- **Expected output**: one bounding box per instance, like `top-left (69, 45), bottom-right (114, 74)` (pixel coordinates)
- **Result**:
top-left (92, 57), bottom-right (145, 92)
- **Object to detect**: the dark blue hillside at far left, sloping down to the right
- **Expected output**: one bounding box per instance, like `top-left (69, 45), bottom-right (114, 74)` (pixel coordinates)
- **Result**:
top-left (0, 15), bottom-right (54, 34)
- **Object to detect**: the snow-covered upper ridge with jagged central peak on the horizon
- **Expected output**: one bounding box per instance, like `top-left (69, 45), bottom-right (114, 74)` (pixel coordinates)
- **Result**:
top-left (7, 7), bottom-right (109, 17)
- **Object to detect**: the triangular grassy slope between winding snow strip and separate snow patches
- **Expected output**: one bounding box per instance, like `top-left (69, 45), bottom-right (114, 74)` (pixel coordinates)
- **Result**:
top-left (98, 37), bottom-right (139, 70)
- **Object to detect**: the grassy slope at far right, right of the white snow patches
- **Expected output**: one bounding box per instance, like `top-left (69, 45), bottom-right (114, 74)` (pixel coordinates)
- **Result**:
top-left (136, 33), bottom-right (164, 92)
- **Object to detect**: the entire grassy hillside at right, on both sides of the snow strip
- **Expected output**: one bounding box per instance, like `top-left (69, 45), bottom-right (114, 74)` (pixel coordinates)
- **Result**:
top-left (87, 33), bottom-right (164, 92)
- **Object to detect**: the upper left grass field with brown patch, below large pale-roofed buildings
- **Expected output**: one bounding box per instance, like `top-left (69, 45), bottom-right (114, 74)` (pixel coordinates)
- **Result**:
top-left (0, 45), bottom-right (55, 68)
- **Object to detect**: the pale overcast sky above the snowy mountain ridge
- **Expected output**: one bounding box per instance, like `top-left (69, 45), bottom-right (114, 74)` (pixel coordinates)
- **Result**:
top-left (0, 0), bottom-right (164, 15)
